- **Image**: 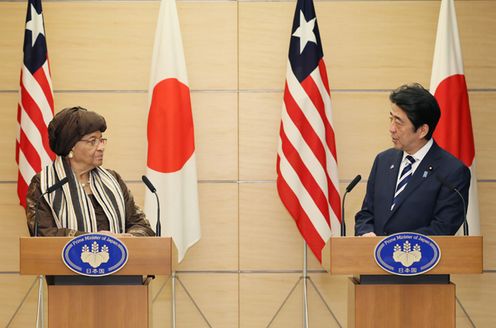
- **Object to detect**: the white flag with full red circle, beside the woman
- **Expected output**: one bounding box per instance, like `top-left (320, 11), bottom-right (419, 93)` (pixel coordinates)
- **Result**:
top-left (145, 0), bottom-right (200, 262)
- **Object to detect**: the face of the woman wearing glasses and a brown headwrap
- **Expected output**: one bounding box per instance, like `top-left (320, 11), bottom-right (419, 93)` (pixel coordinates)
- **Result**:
top-left (71, 131), bottom-right (107, 169)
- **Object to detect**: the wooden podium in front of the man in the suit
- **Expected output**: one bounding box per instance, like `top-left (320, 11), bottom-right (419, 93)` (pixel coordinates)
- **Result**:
top-left (322, 236), bottom-right (482, 328)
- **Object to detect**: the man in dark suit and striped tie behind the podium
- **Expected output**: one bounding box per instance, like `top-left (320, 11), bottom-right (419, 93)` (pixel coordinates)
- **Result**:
top-left (355, 84), bottom-right (470, 237)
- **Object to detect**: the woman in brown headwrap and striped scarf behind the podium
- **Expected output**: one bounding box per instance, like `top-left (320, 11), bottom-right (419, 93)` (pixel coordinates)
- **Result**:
top-left (26, 107), bottom-right (154, 236)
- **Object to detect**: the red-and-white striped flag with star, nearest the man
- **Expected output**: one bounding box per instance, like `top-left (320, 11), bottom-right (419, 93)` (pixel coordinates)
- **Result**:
top-left (277, 0), bottom-right (341, 262)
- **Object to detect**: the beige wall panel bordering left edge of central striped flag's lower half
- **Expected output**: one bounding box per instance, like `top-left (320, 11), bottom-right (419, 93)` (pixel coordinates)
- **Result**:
top-left (239, 183), bottom-right (321, 270)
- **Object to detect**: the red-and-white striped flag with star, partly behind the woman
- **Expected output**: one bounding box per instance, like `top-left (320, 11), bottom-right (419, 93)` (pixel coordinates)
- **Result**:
top-left (16, 0), bottom-right (55, 207)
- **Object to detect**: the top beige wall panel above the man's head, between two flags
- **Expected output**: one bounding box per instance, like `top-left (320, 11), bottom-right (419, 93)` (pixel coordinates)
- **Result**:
top-left (316, 1), bottom-right (438, 89)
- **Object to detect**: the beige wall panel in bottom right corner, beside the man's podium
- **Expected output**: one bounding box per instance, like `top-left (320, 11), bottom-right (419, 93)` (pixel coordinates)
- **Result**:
top-left (452, 272), bottom-right (496, 327)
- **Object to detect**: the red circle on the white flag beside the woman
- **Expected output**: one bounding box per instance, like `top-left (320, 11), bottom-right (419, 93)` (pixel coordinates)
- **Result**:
top-left (148, 79), bottom-right (195, 173)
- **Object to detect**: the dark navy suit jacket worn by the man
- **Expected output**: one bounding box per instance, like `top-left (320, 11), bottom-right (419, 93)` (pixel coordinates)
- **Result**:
top-left (355, 142), bottom-right (470, 236)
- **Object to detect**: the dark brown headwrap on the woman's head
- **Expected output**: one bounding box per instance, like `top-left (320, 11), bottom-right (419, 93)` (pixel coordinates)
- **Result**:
top-left (48, 107), bottom-right (107, 156)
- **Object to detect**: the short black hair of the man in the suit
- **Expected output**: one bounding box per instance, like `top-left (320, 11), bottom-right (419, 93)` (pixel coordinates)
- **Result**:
top-left (389, 83), bottom-right (441, 140)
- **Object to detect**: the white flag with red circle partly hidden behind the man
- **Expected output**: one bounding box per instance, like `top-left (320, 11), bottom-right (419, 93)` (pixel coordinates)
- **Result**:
top-left (430, 0), bottom-right (480, 235)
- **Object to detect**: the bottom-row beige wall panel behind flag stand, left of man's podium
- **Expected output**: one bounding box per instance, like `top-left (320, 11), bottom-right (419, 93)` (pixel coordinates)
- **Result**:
top-left (239, 273), bottom-right (347, 328)
